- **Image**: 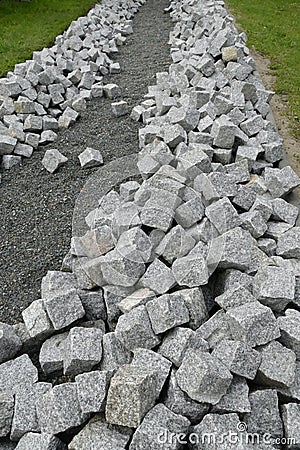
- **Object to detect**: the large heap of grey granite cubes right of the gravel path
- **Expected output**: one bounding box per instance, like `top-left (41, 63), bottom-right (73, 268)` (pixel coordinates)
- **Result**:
top-left (0, 0), bottom-right (300, 450)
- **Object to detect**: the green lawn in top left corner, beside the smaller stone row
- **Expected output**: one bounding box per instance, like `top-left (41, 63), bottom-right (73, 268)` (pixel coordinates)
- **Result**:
top-left (0, 0), bottom-right (96, 76)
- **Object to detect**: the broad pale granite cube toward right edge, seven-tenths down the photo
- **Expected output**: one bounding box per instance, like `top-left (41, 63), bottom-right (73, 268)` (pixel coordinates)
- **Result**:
top-left (226, 301), bottom-right (280, 347)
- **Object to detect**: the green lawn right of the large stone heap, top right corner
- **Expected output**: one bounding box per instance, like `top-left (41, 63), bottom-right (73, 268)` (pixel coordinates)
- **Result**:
top-left (226, 0), bottom-right (300, 137)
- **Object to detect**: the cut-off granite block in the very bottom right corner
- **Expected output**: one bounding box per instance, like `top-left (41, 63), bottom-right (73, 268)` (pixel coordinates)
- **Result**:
top-left (281, 403), bottom-right (300, 450)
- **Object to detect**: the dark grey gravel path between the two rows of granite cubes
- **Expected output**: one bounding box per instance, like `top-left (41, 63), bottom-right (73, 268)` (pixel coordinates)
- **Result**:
top-left (0, 0), bottom-right (171, 324)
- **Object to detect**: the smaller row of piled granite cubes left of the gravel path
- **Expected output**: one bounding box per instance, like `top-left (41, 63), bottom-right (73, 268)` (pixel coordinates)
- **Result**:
top-left (0, 0), bottom-right (138, 174)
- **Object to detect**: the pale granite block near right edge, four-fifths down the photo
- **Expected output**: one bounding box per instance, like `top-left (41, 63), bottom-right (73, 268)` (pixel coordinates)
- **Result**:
top-left (257, 341), bottom-right (296, 388)
